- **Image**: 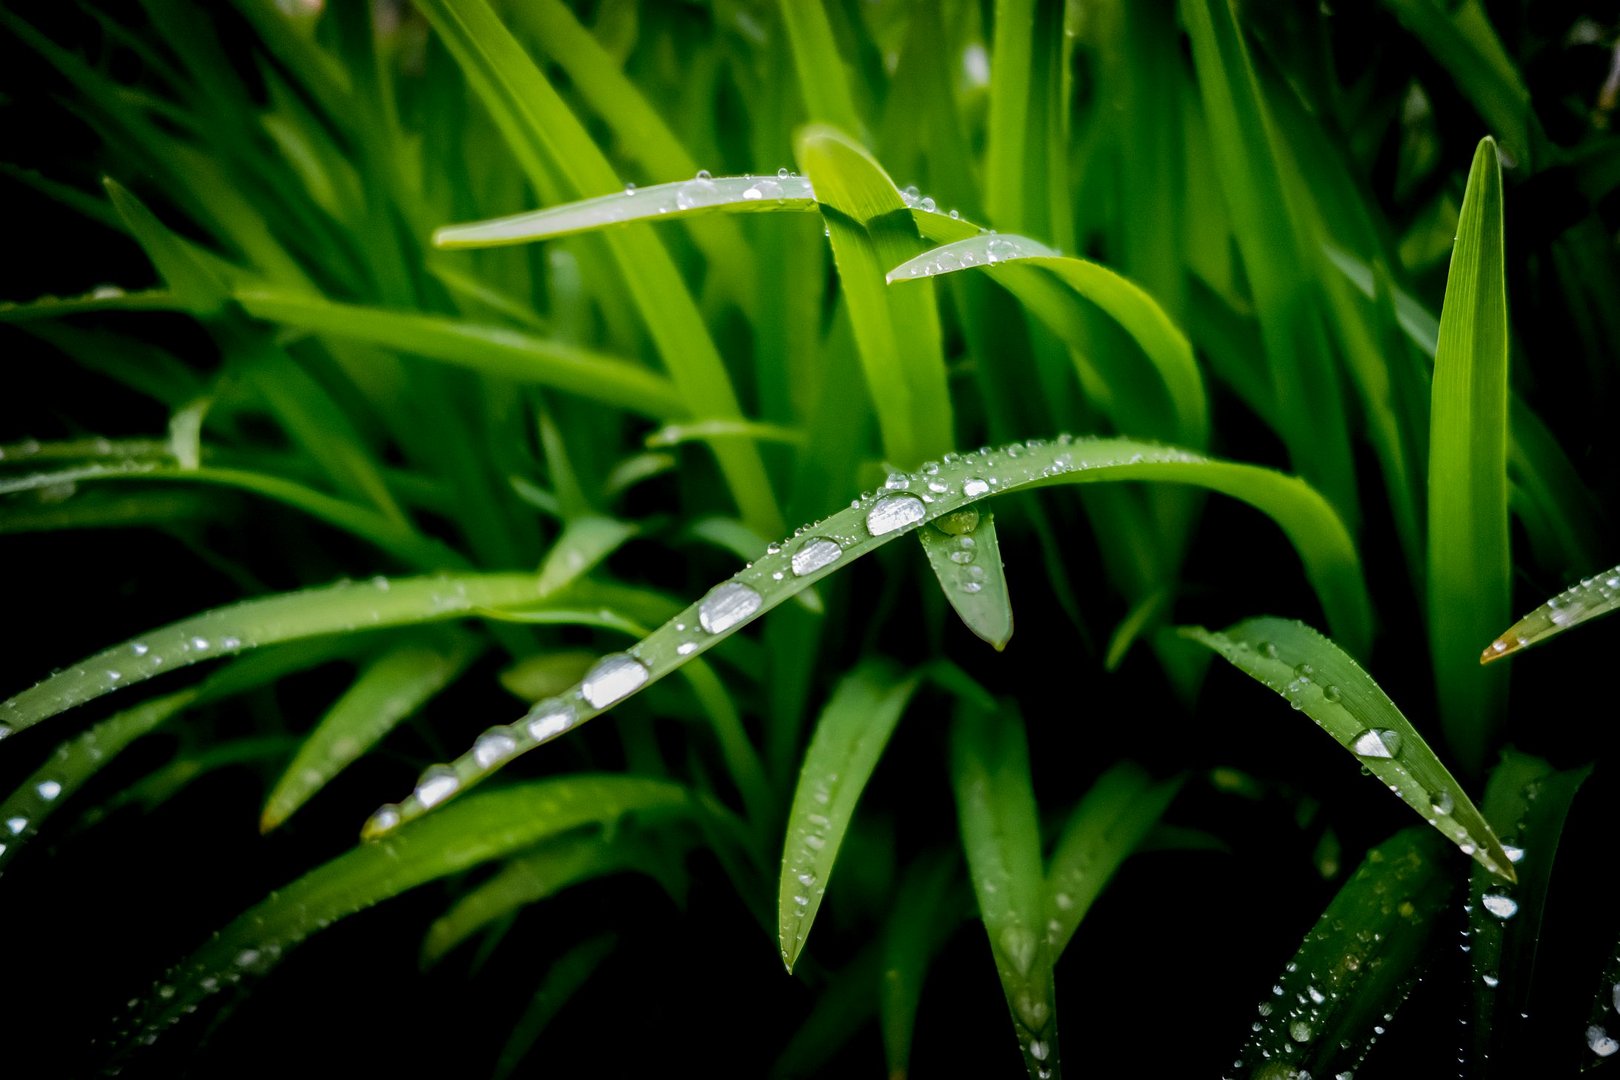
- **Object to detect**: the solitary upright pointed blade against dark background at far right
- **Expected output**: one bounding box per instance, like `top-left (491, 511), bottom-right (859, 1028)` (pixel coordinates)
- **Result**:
top-left (1429, 138), bottom-right (1511, 772)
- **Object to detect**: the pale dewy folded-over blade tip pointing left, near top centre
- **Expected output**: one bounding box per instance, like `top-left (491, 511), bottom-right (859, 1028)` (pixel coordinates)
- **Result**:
top-left (433, 173), bottom-right (816, 249)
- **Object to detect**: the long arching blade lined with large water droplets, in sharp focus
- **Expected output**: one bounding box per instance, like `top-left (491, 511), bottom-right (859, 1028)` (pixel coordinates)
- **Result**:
top-left (372, 436), bottom-right (1371, 836)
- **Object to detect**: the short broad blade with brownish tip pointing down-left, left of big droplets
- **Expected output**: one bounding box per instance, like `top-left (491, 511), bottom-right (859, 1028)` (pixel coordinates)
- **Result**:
top-left (259, 633), bottom-right (481, 832)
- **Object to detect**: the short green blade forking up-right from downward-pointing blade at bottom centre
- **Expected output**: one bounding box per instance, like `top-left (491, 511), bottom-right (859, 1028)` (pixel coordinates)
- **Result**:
top-left (1045, 761), bottom-right (1181, 959)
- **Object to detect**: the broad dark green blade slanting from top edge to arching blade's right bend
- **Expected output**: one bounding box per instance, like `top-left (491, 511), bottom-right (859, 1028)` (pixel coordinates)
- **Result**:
top-left (1181, 0), bottom-right (1359, 529)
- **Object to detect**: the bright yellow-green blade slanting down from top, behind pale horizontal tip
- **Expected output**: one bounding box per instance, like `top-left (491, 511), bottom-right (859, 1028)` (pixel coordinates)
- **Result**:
top-left (408, 0), bottom-right (782, 533)
